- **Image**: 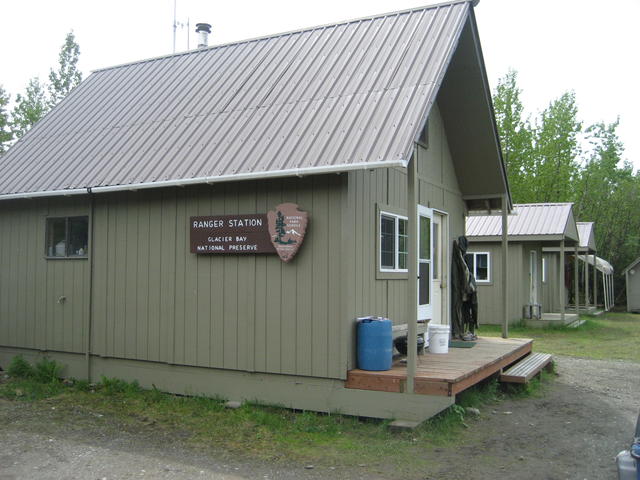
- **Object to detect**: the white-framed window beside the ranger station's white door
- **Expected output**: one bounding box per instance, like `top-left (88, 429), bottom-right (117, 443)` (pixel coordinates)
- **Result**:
top-left (380, 212), bottom-right (409, 272)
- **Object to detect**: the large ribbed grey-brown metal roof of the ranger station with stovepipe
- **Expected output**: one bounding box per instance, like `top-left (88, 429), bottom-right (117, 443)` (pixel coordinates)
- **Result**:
top-left (0, 1), bottom-right (472, 199)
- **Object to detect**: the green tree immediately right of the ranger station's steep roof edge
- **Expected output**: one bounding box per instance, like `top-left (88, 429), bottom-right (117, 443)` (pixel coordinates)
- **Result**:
top-left (493, 70), bottom-right (533, 202)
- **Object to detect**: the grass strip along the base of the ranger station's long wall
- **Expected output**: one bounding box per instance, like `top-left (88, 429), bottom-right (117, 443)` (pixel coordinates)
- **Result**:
top-left (0, 352), bottom-right (552, 476)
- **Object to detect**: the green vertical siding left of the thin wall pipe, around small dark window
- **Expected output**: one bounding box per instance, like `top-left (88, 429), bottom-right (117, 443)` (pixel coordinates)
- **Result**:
top-left (0, 198), bottom-right (89, 352)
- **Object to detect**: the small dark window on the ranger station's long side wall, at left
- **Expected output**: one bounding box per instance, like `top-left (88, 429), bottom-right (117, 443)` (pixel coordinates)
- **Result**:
top-left (45, 217), bottom-right (89, 258)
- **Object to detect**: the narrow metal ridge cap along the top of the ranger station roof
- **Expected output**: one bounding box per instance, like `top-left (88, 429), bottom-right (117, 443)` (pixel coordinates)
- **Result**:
top-left (91, 0), bottom-right (476, 73)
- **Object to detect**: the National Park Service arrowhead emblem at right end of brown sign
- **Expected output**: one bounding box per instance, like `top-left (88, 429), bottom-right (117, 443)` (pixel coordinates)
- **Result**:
top-left (267, 203), bottom-right (309, 262)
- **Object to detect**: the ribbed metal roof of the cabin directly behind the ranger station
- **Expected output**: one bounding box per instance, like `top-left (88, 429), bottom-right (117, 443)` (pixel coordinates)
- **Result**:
top-left (466, 203), bottom-right (578, 241)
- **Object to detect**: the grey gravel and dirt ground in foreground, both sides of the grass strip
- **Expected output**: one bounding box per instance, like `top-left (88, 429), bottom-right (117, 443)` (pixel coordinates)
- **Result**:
top-left (0, 357), bottom-right (640, 480)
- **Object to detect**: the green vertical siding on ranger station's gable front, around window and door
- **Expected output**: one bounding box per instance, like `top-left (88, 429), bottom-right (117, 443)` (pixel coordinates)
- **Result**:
top-left (343, 101), bottom-right (465, 366)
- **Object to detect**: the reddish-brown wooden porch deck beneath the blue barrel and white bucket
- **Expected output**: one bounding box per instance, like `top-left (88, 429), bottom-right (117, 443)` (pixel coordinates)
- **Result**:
top-left (345, 337), bottom-right (533, 396)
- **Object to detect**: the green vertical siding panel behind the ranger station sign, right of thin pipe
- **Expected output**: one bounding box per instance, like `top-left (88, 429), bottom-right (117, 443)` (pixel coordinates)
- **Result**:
top-left (92, 175), bottom-right (346, 378)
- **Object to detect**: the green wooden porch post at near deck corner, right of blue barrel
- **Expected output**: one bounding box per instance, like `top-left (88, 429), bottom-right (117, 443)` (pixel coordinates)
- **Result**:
top-left (406, 148), bottom-right (418, 393)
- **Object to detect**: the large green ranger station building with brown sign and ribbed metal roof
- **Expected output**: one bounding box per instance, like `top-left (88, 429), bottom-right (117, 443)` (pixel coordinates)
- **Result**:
top-left (0, 0), bottom-right (511, 420)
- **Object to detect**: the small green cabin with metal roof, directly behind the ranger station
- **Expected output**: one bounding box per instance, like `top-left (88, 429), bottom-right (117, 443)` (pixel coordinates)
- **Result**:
top-left (466, 203), bottom-right (588, 325)
